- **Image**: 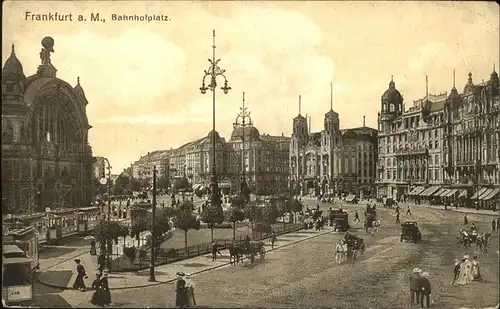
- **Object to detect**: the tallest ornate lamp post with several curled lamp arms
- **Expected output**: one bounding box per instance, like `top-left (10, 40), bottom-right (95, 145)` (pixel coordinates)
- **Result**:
top-left (200, 30), bottom-right (231, 209)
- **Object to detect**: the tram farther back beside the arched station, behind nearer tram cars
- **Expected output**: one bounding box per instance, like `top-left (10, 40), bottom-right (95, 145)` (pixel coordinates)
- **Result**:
top-left (3, 207), bottom-right (100, 245)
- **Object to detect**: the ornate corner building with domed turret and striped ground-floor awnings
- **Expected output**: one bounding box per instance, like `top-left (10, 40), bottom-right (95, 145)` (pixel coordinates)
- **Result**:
top-left (377, 70), bottom-right (500, 208)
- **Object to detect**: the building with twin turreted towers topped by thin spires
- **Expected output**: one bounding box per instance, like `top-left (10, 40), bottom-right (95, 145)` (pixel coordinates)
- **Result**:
top-left (289, 91), bottom-right (377, 196)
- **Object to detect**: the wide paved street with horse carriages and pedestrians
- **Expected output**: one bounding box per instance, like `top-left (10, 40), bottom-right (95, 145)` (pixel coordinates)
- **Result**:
top-left (35, 202), bottom-right (499, 308)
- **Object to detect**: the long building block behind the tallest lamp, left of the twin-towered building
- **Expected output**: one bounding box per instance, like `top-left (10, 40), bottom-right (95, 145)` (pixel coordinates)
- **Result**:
top-left (132, 110), bottom-right (290, 194)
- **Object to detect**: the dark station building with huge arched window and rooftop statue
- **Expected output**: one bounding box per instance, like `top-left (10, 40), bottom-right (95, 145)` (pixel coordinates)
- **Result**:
top-left (2, 37), bottom-right (93, 213)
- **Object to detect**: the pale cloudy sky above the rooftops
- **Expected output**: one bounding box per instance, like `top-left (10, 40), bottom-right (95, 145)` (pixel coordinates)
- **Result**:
top-left (2, 1), bottom-right (500, 173)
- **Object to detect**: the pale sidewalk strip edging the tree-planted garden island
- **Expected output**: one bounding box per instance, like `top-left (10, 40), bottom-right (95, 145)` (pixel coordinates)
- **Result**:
top-left (37, 227), bottom-right (333, 290)
